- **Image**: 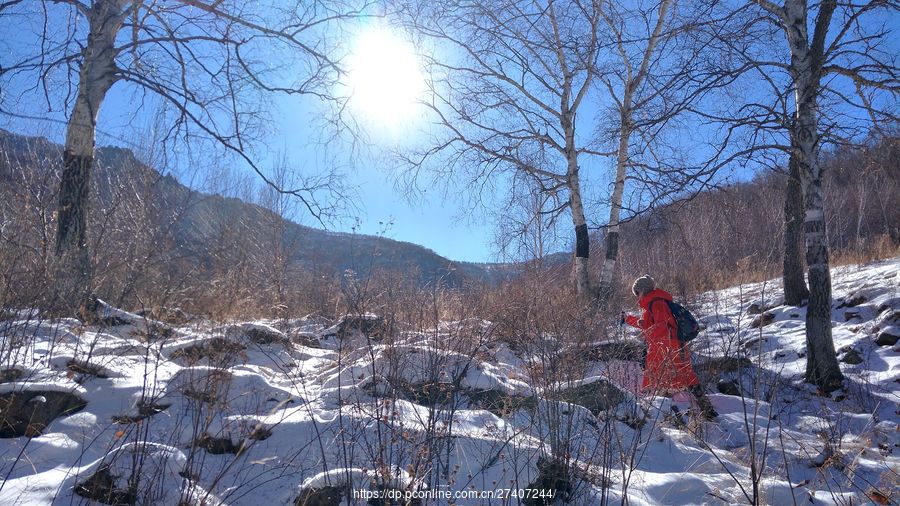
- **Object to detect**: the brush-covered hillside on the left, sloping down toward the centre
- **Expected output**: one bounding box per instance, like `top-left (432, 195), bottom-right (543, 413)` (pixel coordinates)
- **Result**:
top-left (0, 131), bottom-right (540, 312)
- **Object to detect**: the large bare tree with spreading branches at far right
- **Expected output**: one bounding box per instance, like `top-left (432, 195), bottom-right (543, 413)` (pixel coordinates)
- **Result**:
top-left (730, 0), bottom-right (900, 392)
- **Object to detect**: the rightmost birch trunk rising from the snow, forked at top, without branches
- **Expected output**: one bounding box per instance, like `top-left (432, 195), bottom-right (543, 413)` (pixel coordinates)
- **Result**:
top-left (783, 0), bottom-right (843, 393)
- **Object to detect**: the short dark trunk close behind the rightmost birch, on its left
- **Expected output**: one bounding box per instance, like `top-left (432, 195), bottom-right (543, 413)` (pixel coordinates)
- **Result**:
top-left (782, 138), bottom-right (809, 306)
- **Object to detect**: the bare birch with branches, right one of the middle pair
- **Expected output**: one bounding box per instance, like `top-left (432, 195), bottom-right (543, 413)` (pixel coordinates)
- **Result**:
top-left (598, 0), bottom-right (739, 298)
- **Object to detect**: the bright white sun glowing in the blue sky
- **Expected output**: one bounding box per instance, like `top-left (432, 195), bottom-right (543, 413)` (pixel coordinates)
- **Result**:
top-left (346, 28), bottom-right (425, 128)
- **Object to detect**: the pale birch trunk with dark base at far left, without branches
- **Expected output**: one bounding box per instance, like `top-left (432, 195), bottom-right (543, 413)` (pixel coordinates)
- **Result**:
top-left (56, 0), bottom-right (125, 311)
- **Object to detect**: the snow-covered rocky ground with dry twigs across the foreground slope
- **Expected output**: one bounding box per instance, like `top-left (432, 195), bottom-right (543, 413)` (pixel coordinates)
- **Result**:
top-left (0, 259), bottom-right (900, 505)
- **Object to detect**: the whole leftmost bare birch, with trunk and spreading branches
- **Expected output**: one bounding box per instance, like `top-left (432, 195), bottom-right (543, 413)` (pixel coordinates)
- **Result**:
top-left (0, 0), bottom-right (366, 309)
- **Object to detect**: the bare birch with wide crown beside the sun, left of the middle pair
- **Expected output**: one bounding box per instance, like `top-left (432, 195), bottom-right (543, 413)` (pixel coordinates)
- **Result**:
top-left (402, 0), bottom-right (604, 301)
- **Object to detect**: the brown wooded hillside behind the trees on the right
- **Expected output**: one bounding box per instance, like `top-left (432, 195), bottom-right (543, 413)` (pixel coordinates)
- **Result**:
top-left (621, 137), bottom-right (900, 294)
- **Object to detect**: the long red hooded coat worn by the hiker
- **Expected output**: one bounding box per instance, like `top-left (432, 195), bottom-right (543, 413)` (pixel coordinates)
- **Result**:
top-left (625, 288), bottom-right (700, 393)
